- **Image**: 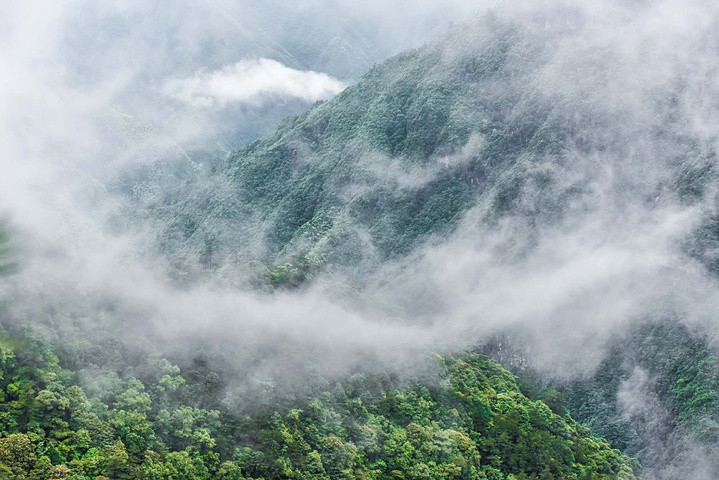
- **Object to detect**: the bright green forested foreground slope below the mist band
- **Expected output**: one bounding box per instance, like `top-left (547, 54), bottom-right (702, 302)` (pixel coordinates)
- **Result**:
top-left (0, 339), bottom-right (636, 480)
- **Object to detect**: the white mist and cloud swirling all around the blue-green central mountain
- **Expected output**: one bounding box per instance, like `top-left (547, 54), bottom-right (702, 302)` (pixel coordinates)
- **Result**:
top-left (0, 0), bottom-right (719, 478)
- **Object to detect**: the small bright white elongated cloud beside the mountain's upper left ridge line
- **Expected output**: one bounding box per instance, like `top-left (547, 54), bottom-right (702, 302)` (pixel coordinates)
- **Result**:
top-left (162, 58), bottom-right (346, 107)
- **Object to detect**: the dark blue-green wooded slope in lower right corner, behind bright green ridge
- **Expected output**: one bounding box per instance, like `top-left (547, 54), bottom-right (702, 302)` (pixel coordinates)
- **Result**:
top-left (556, 321), bottom-right (719, 472)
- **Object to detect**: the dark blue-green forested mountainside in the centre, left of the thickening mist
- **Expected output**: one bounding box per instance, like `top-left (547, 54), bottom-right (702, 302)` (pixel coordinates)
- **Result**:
top-left (133, 16), bottom-right (568, 269)
